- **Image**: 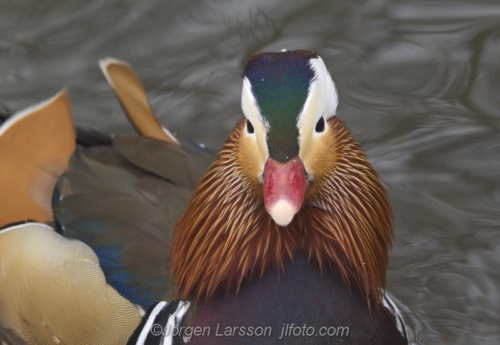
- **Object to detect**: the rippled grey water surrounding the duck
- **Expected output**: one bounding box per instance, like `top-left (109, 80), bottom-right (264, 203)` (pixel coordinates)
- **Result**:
top-left (0, 0), bottom-right (500, 344)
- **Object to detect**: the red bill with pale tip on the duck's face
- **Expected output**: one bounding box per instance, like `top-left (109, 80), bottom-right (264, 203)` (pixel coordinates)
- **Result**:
top-left (264, 157), bottom-right (307, 226)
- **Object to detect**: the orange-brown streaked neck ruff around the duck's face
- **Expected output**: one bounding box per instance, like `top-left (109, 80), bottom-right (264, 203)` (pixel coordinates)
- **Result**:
top-left (172, 117), bottom-right (392, 306)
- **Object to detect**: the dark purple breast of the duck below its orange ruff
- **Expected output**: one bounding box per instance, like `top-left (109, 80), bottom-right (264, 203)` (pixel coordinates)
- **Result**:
top-left (189, 252), bottom-right (405, 345)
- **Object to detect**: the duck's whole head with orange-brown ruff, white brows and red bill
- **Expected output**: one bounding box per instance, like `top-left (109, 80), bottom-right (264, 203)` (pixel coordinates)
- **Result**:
top-left (172, 50), bottom-right (392, 304)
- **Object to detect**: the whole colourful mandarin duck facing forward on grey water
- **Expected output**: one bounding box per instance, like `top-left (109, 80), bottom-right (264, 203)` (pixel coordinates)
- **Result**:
top-left (0, 50), bottom-right (407, 345)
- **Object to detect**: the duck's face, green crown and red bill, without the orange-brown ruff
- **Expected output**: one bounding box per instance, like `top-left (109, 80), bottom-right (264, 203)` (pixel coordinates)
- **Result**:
top-left (241, 51), bottom-right (337, 227)
